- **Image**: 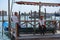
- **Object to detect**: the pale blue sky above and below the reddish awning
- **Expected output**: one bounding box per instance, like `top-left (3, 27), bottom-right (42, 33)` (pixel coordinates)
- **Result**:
top-left (0, 0), bottom-right (60, 13)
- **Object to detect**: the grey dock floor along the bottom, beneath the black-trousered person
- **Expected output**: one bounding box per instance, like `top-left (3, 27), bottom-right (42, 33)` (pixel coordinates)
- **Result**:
top-left (11, 31), bottom-right (60, 40)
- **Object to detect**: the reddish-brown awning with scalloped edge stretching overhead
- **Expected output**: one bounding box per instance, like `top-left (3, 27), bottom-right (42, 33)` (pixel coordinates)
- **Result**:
top-left (15, 1), bottom-right (60, 7)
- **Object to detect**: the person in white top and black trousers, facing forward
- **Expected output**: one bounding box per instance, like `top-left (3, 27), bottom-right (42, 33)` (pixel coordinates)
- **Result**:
top-left (39, 16), bottom-right (46, 35)
